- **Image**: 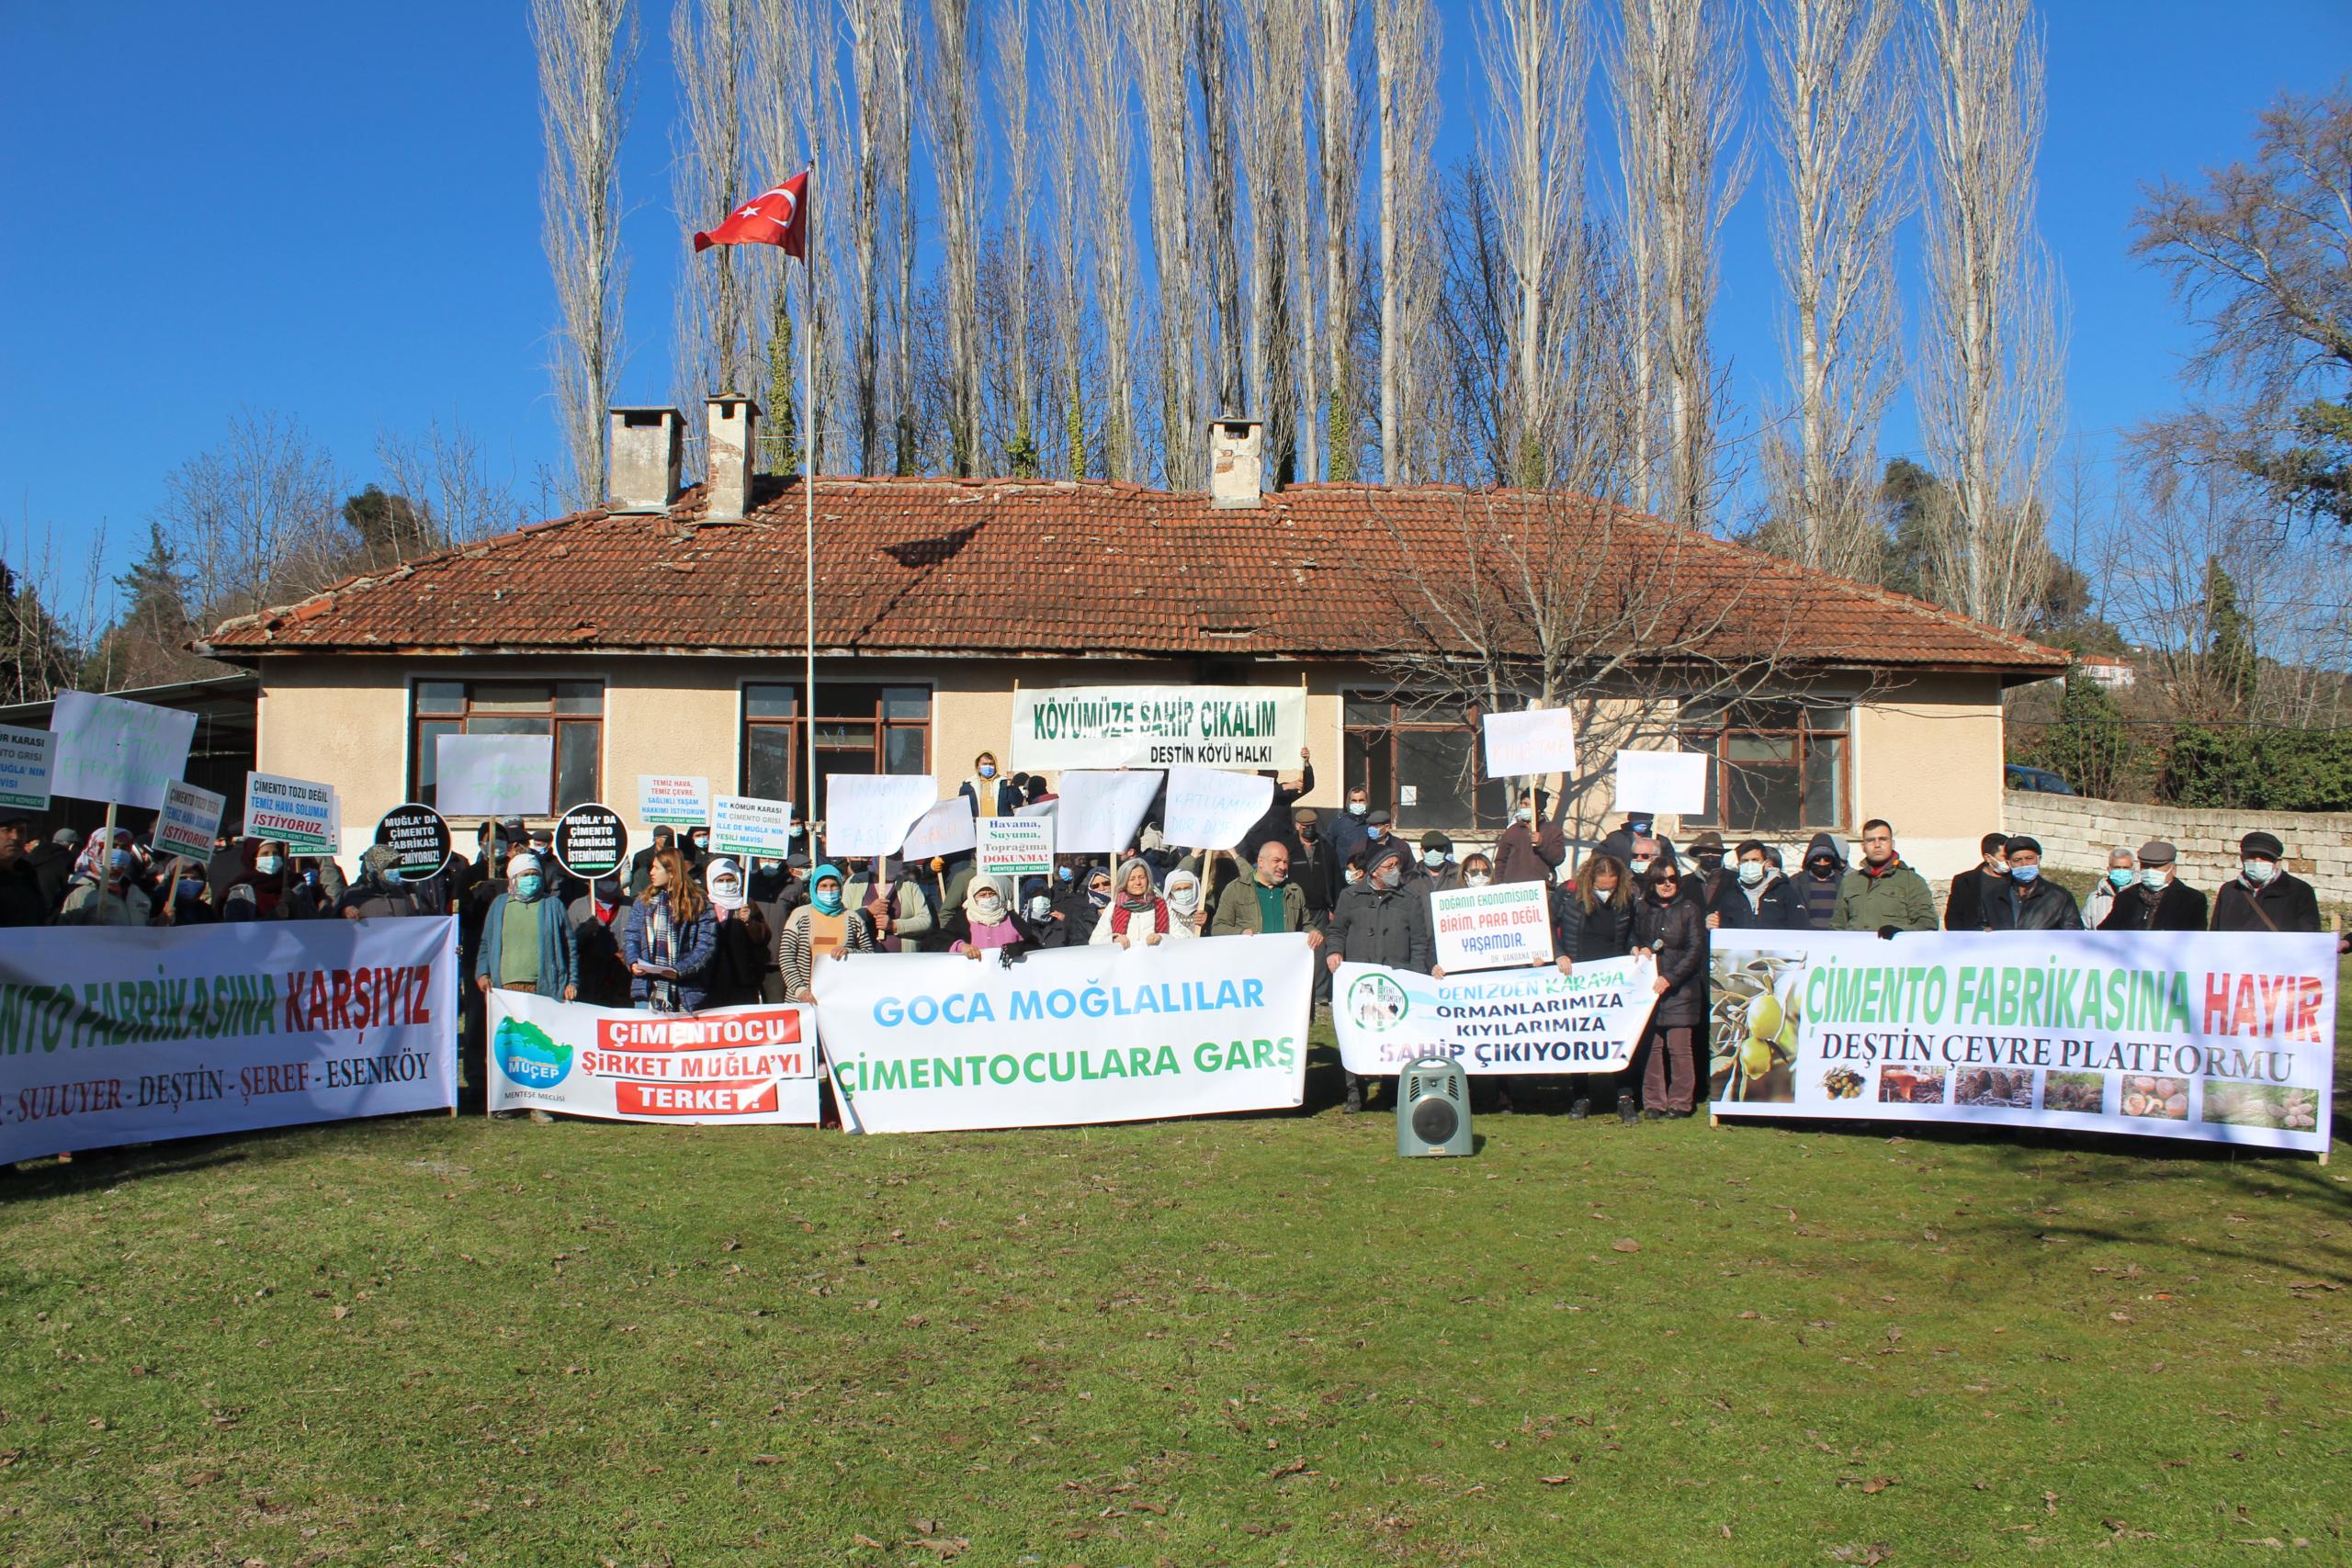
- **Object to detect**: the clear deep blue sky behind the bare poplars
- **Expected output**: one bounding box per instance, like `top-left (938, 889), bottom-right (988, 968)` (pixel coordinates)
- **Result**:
top-left (0, 0), bottom-right (2352, 620)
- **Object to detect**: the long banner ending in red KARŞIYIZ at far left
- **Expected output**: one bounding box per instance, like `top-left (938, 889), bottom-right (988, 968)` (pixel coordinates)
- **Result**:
top-left (0, 917), bottom-right (457, 1161)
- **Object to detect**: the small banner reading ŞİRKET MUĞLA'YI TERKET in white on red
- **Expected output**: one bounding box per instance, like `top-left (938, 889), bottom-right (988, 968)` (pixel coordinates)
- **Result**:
top-left (489, 989), bottom-right (816, 1126)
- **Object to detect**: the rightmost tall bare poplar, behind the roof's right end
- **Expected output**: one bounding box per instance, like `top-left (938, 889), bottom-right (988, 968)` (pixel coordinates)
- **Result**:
top-left (1915, 0), bottom-right (2063, 627)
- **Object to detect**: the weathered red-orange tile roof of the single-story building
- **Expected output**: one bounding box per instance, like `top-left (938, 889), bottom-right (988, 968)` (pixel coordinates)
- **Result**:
top-left (205, 478), bottom-right (2065, 680)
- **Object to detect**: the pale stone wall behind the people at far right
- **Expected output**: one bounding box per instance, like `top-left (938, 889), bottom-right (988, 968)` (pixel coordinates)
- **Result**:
top-left (2002, 790), bottom-right (2352, 903)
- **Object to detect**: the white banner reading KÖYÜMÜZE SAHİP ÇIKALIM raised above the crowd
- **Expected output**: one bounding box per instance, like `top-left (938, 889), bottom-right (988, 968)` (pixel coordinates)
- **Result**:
top-left (1012, 686), bottom-right (1307, 773)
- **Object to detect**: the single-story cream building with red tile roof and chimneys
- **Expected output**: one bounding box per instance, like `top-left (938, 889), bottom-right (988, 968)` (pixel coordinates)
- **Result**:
top-left (200, 398), bottom-right (2065, 874)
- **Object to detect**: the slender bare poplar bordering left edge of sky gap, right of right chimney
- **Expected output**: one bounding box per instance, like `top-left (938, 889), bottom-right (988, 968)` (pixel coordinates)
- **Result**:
top-left (1371, 0), bottom-right (1442, 484)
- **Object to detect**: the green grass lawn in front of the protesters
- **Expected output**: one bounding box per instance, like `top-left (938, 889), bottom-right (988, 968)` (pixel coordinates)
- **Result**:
top-left (0, 973), bottom-right (2352, 1568)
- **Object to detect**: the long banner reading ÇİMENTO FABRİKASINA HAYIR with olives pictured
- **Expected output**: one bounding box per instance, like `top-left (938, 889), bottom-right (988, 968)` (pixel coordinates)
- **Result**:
top-left (1710, 931), bottom-right (2335, 1152)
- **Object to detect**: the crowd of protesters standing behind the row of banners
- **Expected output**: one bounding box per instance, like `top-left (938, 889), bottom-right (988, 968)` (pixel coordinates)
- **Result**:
top-left (14, 752), bottom-right (2322, 1122)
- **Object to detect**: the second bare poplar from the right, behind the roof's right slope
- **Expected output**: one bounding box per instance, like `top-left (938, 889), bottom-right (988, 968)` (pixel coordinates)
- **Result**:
top-left (1764, 0), bottom-right (1910, 579)
